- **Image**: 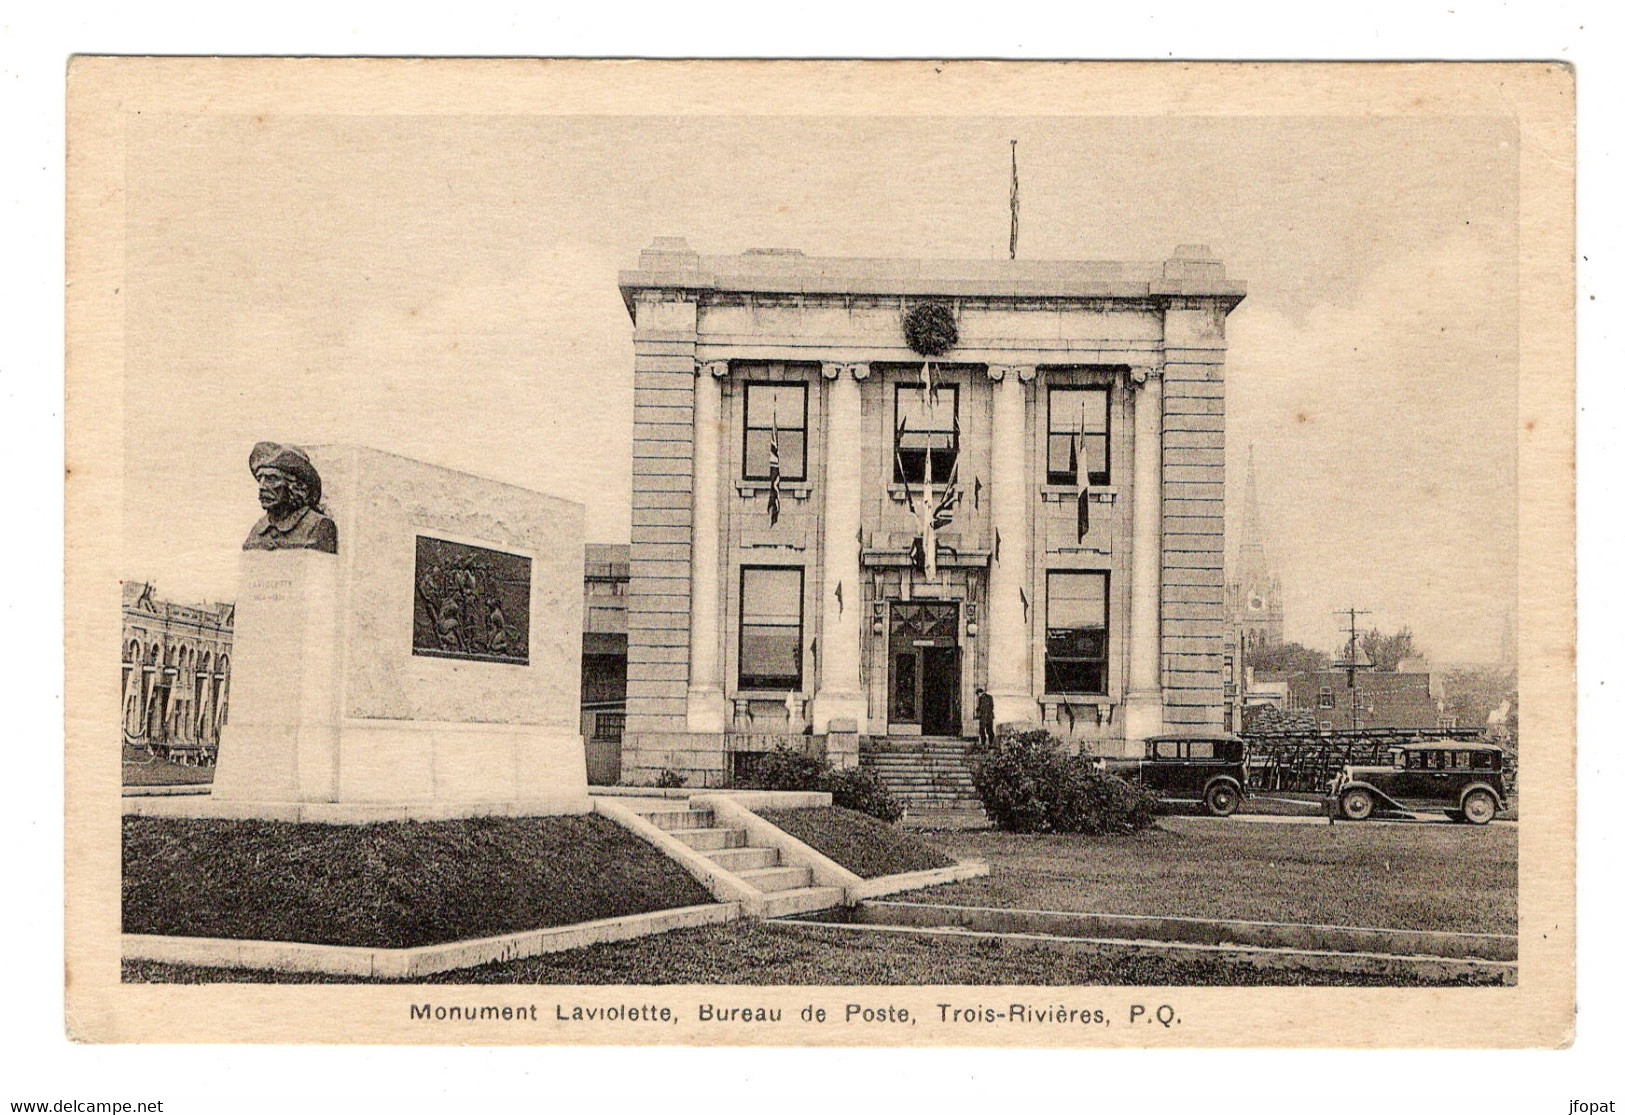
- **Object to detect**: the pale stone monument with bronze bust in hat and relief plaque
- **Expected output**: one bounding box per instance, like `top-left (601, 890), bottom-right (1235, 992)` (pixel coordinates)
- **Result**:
top-left (208, 442), bottom-right (588, 822)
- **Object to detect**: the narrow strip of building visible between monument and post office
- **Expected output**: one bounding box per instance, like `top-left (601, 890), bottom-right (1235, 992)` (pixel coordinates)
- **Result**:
top-left (582, 543), bottom-right (632, 785)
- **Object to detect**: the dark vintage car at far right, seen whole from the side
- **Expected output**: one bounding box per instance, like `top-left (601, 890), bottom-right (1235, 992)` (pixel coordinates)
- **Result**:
top-left (1328, 740), bottom-right (1506, 824)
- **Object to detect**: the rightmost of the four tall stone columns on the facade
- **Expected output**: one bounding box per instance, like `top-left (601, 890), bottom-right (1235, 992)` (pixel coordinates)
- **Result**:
top-left (1123, 367), bottom-right (1162, 741)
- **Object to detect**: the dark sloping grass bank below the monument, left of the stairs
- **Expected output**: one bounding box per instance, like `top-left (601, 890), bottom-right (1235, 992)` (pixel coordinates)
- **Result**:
top-left (124, 814), bottom-right (713, 948)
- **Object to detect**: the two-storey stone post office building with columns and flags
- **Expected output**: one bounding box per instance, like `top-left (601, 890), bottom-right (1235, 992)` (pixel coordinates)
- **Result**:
top-left (621, 239), bottom-right (1246, 787)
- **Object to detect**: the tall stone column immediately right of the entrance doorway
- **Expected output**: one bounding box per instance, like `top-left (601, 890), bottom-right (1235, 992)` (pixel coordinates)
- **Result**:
top-left (985, 364), bottom-right (1042, 723)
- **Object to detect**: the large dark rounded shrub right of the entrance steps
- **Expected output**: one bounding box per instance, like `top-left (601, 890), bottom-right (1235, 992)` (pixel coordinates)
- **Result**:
top-left (970, 730), bottom-right (1157, 835)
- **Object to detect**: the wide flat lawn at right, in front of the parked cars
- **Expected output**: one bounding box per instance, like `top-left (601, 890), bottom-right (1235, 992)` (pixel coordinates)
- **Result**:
top-left (895, 818), bottom-right (1518, 933)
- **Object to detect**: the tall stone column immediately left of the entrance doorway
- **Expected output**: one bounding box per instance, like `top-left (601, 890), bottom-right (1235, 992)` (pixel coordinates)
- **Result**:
top-left (813, 364), bottom-right (869, 735)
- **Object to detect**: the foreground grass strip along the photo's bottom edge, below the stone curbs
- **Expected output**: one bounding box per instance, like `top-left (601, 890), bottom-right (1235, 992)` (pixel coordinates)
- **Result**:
top-left (124, 922), bottom-right (1501, 987)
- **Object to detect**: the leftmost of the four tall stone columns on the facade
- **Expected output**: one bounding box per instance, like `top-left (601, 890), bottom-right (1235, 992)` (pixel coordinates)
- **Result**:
top-left (687, 361), bottom-right (728, 731)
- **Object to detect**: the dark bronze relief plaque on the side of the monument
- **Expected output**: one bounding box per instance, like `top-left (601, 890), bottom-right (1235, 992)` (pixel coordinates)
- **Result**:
top-left (411, 535), bottom-right (530, 666)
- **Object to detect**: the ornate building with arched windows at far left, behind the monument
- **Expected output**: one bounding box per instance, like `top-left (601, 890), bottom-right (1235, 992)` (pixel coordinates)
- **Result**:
top-left (122, 580), bottom-right (236, 762)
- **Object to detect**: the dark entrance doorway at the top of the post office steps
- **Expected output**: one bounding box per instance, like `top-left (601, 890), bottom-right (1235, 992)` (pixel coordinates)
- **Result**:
top-left (887, 600), bottom-right (960, 736)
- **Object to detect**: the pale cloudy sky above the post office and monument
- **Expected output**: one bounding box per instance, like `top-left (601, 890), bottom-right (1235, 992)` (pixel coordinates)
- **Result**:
top-left (124, 115), bottom-right (1518, 662)
